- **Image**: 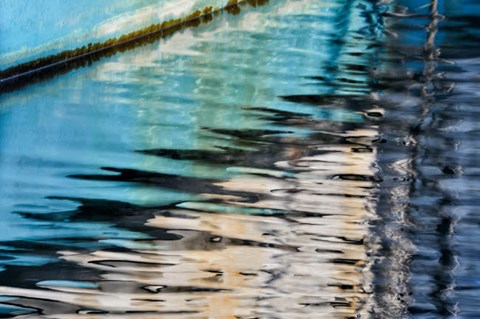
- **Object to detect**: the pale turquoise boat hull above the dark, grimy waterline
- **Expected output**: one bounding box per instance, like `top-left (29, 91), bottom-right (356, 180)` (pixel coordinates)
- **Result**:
top-left (0, 0), bottom-right (232, 71)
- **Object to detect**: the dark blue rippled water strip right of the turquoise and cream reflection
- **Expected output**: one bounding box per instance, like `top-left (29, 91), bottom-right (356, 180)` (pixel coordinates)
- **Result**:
top-left (374, 1), bottom-right (480, 318)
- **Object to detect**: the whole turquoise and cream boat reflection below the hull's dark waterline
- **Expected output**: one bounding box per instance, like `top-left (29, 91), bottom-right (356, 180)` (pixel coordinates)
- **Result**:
top-left (0, 1), bottom-right (381, 318)
